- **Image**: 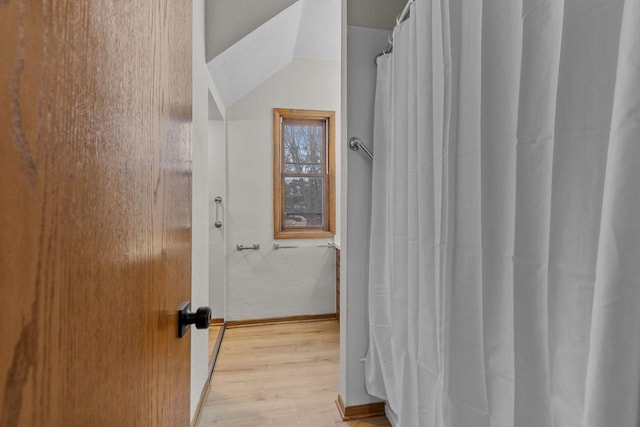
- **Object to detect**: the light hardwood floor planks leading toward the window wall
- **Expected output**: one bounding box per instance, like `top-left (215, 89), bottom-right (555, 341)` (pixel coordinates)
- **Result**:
top-left (198, 320), bottom-right (390, 427)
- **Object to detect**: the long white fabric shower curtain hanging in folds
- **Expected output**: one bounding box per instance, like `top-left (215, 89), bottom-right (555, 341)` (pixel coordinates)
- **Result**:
top-left (365, 0), bottom-right (640, 427)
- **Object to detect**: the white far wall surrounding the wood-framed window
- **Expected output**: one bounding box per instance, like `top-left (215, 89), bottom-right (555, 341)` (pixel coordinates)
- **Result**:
top-left (225, 59), bottom-right (341, 320)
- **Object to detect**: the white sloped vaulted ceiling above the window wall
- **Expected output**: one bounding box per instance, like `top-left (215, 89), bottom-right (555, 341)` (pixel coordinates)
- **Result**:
top-left (207, 0), bottom-right (341, 108)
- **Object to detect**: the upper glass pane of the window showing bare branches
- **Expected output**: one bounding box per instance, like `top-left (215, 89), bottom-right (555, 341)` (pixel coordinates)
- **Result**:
top-left (283, 121), bottom-right (325, 173)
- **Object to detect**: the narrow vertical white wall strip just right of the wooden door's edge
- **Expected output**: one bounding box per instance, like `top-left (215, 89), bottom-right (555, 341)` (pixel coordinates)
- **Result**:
top-left (189, 0), bottom-right (209, 419)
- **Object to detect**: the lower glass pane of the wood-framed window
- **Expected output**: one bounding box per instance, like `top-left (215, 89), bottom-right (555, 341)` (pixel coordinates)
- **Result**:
top-left (284, 177), bottom-right (324, 228)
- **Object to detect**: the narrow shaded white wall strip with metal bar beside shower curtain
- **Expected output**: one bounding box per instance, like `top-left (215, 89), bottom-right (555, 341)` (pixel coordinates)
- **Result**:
top-left (340, 25), bottom-right (390, 406)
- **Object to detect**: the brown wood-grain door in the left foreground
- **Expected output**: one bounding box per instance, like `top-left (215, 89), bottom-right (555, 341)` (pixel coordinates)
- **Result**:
top-left (0, 0), bottom-right (192, 426)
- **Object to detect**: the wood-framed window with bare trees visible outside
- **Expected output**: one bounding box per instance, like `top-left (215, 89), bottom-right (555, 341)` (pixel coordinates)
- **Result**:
top-left (273, 108), bottom-right (335, 239)
